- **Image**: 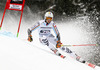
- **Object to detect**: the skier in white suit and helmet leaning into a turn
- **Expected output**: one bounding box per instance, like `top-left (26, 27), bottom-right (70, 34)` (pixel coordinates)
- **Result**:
top-left (28, 12), bottom-right (85, 63)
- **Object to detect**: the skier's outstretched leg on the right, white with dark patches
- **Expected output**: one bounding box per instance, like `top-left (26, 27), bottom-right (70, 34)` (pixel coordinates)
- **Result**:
top-left (60, 46), bottom-right (85, 63)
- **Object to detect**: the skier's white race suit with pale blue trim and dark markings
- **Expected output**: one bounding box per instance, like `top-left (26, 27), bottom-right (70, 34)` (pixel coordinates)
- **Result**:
top-left (30, 20), bottom-right (82, 59)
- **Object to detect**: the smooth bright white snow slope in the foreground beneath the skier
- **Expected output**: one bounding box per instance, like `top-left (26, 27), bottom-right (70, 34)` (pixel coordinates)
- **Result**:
top-left (0, 32), bottom-right (97, 70)
